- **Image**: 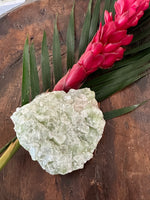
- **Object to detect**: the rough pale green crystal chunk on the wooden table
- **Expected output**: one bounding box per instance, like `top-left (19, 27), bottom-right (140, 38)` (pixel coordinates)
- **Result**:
top-left (11, 88), bottom-right (105, 174)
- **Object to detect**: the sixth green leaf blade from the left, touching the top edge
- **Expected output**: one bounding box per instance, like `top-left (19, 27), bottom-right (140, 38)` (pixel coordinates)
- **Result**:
top-left (79, 0), bottom-right (92, 58)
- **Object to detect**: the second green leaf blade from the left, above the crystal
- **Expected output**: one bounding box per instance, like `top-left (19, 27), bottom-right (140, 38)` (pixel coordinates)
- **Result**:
top-left (30, 43), bottom-right (40, 99)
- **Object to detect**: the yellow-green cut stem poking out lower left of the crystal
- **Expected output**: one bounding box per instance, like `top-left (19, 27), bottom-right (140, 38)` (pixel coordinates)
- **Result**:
top-left (0, 139), bottom-right (20, 170)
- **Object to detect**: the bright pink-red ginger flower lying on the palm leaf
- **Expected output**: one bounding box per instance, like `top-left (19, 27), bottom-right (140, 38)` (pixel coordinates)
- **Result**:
top-left (54, 0), bottom-right (150, 92)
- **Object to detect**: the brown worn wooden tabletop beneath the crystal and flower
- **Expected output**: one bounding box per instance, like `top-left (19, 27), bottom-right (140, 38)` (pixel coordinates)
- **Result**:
top-left (0, 0), bottom-right (150, 200)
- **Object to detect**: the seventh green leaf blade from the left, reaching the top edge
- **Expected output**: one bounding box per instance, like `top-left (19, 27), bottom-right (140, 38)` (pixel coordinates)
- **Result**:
top-left (89, 0), bottom-right (101, 42)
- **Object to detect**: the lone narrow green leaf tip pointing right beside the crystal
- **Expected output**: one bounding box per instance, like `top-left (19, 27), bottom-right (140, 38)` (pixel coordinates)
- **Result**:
top-left (104, 100), bottom-right (148, 120)
